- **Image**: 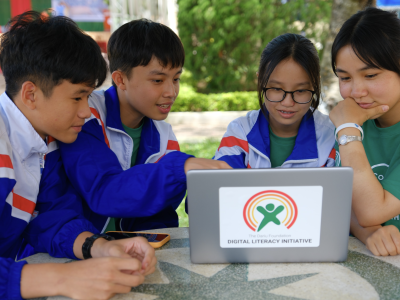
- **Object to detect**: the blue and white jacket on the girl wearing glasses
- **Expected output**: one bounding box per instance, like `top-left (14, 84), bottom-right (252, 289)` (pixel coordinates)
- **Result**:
top-left (214, 110), bottom-right (336, 168)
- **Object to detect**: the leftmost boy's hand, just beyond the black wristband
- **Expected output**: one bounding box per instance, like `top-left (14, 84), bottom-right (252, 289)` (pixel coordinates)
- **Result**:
top-left (91, 237), bottom-right (157, 276)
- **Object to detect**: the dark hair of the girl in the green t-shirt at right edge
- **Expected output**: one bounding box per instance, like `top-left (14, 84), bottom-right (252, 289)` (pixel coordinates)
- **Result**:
top-left (332, 7), bottom-right (400, 75)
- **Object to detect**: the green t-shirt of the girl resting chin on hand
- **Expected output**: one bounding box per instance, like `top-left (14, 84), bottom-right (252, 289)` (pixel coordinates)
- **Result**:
top-left (335, 120), bottom-right (400, 230)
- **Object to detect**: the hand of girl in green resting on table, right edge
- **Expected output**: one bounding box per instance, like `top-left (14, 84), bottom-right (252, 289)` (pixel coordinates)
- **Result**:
top-left (365, 225), bottom-right (400, 256)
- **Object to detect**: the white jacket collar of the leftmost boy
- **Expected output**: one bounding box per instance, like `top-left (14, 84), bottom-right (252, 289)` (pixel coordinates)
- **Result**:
top-left (0, 92), bottom-right (48, 160)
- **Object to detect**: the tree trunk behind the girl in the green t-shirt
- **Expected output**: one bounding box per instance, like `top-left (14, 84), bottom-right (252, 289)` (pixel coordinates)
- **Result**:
top-left (321, 0), bottom-right (376, 112)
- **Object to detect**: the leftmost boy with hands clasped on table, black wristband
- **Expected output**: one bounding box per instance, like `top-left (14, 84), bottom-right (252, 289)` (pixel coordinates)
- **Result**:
top-left (0, 12), bottom-right (155, 299)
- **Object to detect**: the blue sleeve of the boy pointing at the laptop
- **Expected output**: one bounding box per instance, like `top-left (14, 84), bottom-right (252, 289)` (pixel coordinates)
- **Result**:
top-left (59, 121), bottom-right (191, 218)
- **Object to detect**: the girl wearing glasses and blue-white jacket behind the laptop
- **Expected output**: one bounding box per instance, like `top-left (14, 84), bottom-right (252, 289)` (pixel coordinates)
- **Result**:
top-left (214, 33), bottom-right (336, 168)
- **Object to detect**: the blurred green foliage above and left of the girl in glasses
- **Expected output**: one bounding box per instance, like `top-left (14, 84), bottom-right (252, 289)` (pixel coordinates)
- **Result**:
top-left (178, 0), bottom-right (332, 93)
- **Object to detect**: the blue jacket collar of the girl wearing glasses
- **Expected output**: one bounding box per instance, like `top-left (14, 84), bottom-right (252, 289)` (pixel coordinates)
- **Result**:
top-left (247, 109), bottom-right (318, 161)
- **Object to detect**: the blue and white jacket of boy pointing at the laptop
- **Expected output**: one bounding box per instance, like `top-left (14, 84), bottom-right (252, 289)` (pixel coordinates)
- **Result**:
top-left (59, 87), bottom-right (191, 231)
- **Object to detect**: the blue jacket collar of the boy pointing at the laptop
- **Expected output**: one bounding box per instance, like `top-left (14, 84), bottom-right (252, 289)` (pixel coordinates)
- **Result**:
top-left (104, 86), bottom-right (160, 164)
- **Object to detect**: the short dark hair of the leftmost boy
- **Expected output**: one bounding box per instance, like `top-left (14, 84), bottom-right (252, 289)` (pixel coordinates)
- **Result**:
top-left (0, 11), bottom-right (107, 98)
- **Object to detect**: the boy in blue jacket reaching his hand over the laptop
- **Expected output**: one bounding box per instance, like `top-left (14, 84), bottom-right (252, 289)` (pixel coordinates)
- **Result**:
top-left (59, 20), bottom-right (229, 231)
